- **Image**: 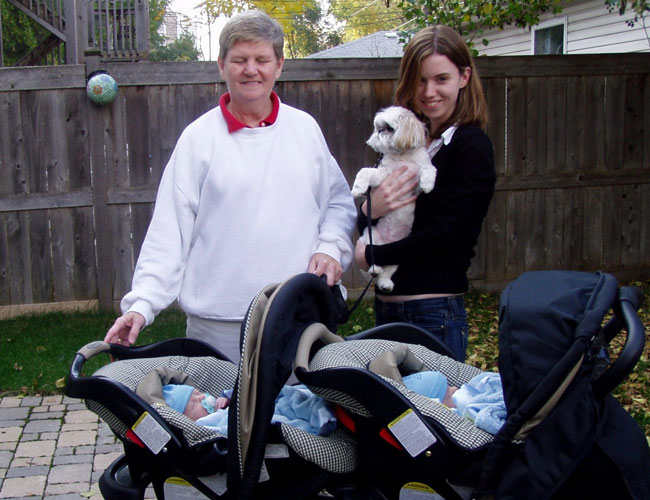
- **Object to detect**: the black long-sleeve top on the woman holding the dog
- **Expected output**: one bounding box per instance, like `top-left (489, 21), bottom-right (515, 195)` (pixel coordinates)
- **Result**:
top-left (357, 125), bottom-right (496, 295)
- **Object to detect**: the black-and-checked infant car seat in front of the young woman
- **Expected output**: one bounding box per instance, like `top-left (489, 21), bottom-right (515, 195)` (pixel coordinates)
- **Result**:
top-left (296, 324), bottom-right (493, 499)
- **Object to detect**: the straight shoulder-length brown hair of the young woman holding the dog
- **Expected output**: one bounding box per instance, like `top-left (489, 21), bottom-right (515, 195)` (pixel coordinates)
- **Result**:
top-left (395, 25), bottom-right (487, 137)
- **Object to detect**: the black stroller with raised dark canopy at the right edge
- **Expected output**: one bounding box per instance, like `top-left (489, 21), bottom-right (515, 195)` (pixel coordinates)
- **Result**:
top-left (296, 271), bottom-right (650, 500)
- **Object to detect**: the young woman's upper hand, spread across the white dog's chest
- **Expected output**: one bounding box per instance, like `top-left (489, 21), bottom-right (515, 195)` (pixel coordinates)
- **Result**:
top-left (355, 165), bottom-right (418, 218)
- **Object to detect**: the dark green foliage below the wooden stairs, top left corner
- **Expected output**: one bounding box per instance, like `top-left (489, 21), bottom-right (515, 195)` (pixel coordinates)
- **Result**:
top-left (0, 0), bottom-right (49, 66)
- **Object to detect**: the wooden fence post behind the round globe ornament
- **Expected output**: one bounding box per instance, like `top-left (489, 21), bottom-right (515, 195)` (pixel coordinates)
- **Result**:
top-left (85, 49), bottom-right (113, 312)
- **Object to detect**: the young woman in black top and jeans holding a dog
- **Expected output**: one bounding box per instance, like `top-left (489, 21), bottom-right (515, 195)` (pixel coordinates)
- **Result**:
top-left (355, 26), bottom-right (496, 361)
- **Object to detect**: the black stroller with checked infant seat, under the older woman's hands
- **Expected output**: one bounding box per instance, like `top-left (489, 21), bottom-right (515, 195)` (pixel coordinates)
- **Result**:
top-left (65, 274), bottom-right (356, 500)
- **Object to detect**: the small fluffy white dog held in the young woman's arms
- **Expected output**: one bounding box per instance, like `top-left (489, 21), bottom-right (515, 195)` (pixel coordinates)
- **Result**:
top-left (352, 106), bottom-right (436, 292)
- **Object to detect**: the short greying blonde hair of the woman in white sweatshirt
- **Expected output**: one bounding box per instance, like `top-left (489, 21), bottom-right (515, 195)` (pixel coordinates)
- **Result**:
top-left (219, 10), bottom-right (284, 61)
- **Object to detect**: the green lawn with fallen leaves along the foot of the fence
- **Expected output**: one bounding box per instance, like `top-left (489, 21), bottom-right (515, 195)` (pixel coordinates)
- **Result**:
top-left (0, 280), bottom-right (650, 437)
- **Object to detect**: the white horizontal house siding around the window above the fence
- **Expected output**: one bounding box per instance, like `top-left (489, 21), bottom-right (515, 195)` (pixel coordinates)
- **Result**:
top-left (474, 0), bottom-right (650, 56)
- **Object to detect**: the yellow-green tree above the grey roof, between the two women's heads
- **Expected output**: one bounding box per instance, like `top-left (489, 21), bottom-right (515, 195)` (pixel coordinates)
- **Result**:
top-left (330, 0), bottom-right (406, 42)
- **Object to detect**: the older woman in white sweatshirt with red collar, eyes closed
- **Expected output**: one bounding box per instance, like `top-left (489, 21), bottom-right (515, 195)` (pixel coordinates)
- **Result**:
top-left (105, 11), bottom-right (356, 362)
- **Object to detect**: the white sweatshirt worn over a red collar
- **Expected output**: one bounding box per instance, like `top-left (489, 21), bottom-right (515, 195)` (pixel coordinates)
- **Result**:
top-left (121, 104), bottom-right (356, 324)
